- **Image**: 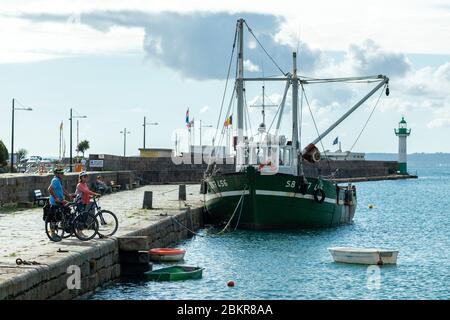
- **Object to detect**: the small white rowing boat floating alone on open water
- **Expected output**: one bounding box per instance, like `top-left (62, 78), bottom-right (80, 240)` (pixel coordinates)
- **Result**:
top-left (328, 247), bottom-right (398, 265)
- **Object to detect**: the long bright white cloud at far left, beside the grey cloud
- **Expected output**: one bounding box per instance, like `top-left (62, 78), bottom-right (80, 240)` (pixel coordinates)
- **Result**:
top-left (0, 16), bottom-right (144, 63)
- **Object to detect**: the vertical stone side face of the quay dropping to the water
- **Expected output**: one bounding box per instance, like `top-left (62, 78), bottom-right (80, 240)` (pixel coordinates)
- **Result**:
top-left (0, 208), bottom-right (203, 300)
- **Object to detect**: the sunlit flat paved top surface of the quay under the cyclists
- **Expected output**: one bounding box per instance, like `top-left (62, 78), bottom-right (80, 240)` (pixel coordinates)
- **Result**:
top-left (0, 185), bottom-right (203, 264)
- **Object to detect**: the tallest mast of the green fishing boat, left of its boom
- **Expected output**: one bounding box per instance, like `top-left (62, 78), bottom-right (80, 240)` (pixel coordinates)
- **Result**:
top-left (236, 19), bottom-right (244, 145)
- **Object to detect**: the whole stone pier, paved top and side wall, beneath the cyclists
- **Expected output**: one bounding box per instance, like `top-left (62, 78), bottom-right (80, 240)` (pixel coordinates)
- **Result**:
top-left (0, 185), bottom-right (203, 300)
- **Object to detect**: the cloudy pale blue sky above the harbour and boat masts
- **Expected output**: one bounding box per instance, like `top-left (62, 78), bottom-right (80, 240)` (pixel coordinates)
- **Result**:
top-left (0, 0), bottom-right (450, 157)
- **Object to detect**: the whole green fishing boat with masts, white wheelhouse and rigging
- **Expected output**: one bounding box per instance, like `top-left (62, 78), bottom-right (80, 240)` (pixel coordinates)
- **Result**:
top-left (202, 19), bottom-right (389, 229)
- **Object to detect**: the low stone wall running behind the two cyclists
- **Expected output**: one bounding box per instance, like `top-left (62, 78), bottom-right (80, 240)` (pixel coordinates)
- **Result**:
top-left (0, 171), bottom-right (136, 205)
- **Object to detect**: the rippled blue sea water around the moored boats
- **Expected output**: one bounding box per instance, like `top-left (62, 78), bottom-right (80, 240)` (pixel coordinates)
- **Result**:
top-left (92, 164), bottom-right (450, 299)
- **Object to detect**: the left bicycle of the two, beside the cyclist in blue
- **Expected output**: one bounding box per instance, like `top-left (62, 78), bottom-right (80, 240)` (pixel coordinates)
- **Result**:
top-left (45, 202), bottom-right (98, 242)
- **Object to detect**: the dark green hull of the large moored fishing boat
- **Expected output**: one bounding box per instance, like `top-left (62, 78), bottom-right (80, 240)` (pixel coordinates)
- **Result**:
top-left (205, 170), bottom-right (356, 229)
